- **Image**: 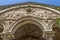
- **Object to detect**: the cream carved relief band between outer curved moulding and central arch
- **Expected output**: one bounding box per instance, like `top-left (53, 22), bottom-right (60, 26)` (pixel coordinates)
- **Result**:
top-left (0, 8), bottom-right (59, 19)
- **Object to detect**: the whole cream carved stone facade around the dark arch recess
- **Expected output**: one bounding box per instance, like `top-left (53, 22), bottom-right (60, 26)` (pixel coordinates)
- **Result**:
top-left (0, 3), bottom-right (60, 40)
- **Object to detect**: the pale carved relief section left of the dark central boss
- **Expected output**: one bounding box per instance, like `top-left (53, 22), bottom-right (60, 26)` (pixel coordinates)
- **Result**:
top-left (1, 9), bottom-right (26, 19)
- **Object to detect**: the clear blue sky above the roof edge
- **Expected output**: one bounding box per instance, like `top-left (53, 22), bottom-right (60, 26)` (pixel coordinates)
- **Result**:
top-left (0, 0), bottom-right (60, 6)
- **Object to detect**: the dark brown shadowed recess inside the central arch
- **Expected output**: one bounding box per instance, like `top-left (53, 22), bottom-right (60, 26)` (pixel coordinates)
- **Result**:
top-left (15, 23), bottom-right (43, 40)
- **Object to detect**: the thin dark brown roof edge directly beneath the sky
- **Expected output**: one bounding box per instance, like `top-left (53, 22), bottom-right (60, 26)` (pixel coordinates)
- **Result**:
top-left (0, 2), bottom-right (57, 10)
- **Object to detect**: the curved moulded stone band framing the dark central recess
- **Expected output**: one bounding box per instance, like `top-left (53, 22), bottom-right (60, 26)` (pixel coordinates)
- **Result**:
top-left (10, 16), bottom-right (46, 33)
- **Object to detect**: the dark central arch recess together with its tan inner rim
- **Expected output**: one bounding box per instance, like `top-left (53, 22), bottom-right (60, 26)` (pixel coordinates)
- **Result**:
top-left (13, 19), bottom-right (44, 40)
